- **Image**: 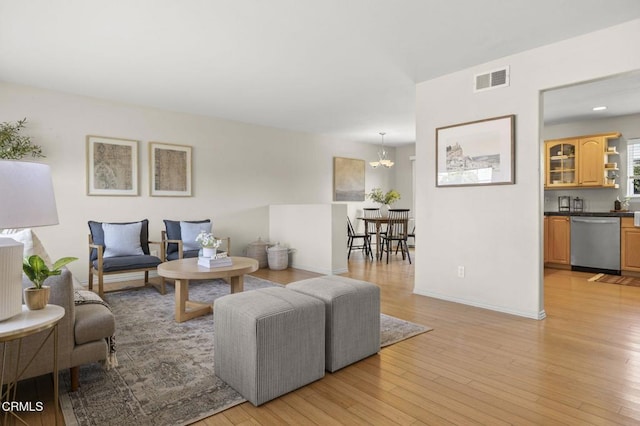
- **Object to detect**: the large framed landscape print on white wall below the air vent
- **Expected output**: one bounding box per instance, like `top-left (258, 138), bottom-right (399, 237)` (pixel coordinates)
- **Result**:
top-left (436, 115), bottom-right (515, 187)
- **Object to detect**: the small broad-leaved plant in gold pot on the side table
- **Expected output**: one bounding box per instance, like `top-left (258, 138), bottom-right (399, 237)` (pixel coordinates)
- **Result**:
top-left (22, 254), bottom-right (78, 311)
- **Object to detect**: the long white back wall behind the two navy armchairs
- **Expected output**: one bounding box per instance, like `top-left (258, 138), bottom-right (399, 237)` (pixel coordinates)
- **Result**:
top-left (0, 82), bottom-right (394, 282)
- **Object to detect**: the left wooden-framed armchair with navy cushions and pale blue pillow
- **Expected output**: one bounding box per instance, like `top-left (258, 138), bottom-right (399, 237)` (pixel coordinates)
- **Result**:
top-left (88, 219), bottom-right (165, 297)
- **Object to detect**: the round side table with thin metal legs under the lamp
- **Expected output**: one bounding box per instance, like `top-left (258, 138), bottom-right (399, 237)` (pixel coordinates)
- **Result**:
top-left (0, 305), bottom-right (65, 425)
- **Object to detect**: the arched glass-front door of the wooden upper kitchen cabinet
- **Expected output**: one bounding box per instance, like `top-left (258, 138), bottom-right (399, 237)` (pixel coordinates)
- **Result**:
top-left (545, 141), bottom-right (578, 187)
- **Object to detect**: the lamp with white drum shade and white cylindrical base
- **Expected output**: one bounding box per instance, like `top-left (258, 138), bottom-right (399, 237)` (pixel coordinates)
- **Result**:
top-left (0, 160), bottom-right (58, 321)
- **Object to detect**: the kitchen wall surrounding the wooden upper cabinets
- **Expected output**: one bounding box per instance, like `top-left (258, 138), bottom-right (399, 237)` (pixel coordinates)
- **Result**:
top-left (543, 114), bottom-right (640, 212)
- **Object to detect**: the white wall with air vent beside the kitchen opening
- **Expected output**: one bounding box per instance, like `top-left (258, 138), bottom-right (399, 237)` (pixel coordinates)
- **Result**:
top-left (415, 20), bottom-right (640, 318)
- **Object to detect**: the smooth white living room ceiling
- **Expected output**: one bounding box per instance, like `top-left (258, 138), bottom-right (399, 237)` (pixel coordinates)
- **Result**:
top-left (0, 0), bottom-right (640, 144)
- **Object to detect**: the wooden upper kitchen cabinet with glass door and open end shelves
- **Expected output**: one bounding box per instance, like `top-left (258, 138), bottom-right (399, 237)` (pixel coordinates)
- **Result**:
top-left (544, 133), bottom-right (620, 189)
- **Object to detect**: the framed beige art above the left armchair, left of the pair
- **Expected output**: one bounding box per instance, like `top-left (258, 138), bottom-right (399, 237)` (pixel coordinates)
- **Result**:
top-left (87, 135), bottom-right (139, 196)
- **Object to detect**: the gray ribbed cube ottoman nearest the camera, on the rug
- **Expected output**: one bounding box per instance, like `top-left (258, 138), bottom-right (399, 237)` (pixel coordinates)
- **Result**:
top-left (213, 287), bottom-right (325, 406)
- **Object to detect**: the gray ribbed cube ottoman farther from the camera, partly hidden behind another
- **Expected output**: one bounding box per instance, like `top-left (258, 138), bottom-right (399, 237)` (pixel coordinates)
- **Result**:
top-left (287, 275), bottom-right (380, 372)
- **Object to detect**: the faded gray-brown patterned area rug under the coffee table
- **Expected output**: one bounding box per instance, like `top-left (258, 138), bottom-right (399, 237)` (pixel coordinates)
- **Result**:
top-left (60, 276), bottom-right (431, 426)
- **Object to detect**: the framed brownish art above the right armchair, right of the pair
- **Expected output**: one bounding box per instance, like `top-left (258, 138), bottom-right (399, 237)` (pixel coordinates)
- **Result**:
top-left (149, 142), bottom-right (192, 197)
